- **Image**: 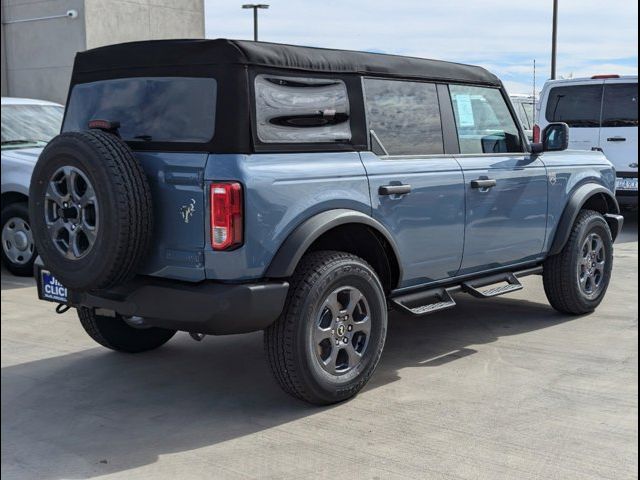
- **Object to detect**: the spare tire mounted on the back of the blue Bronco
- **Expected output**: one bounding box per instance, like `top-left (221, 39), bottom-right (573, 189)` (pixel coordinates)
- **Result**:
top-left (29, 130), bottom-right (153, 291)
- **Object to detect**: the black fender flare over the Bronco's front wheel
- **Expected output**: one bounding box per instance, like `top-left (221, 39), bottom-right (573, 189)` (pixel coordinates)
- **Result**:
top-left (549, 183), bottom-right (620, 255)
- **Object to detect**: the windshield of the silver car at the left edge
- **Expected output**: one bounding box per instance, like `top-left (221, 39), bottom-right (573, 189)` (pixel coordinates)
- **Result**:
top-left (2, 105), bottom-right (64, 149)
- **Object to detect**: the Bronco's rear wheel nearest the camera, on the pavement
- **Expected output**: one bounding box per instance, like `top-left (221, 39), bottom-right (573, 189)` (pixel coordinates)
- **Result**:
top-left (264, 251), bottom-right (387, 405)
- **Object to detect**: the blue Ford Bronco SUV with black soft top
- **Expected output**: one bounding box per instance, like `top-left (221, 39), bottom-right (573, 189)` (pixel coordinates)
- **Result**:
top-left (30, 40), bottom-right (623, 404)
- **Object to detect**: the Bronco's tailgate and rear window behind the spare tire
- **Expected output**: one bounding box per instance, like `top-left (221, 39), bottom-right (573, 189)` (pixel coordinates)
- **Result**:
top-left (63, 77), bottom-right (217, 281)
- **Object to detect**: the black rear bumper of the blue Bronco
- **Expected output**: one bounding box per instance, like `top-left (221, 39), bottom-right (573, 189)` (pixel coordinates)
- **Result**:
top-left (68, 277), bottom-right (289, 335)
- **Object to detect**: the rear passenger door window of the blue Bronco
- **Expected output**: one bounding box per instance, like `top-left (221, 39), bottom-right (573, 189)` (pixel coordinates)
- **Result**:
top-left (364, 78), bottom-right (444, 155)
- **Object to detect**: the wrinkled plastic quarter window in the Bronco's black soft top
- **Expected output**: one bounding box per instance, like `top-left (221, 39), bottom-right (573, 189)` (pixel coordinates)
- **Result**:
top-left (255, 75), bottom-right (351, 143)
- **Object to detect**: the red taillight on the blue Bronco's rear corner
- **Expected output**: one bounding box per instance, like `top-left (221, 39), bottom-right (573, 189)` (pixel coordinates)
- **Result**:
top-left (210, 182), bottom-right (242, 250)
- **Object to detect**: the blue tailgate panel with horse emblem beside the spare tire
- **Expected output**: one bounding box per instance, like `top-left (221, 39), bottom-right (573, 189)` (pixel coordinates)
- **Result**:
top-left (136, 152), bottom-right (207, 281)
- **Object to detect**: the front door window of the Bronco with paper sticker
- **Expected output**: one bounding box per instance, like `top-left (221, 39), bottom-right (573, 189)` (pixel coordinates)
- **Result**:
top-left (449, 85), bottom-right (523, 153)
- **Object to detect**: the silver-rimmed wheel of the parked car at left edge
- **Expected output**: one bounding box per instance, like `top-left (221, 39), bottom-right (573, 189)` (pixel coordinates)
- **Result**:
top-left (2, 202), bottom-right (38, 277)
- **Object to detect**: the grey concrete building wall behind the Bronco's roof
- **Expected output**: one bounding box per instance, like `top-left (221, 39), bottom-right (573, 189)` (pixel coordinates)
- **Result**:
top-left (2, 0), bottom-right (204, 103)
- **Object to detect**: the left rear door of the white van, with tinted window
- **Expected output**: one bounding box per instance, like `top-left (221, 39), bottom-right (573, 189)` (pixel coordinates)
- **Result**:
top-left (540, 80), bottom-right (604, 150)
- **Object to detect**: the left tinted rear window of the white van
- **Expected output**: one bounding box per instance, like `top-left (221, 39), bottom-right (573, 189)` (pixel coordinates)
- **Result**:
top-left (546, 84), bottom-right (602, 127)
